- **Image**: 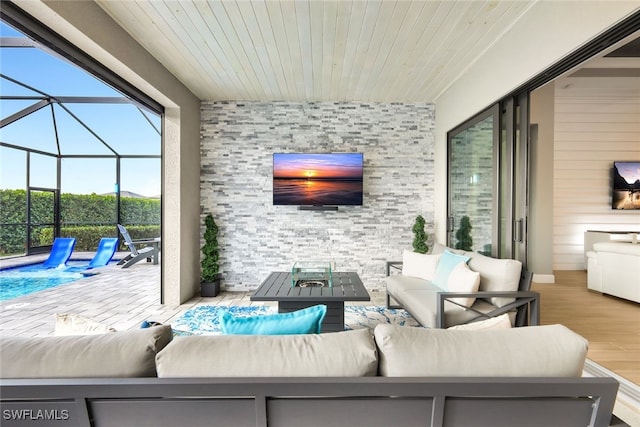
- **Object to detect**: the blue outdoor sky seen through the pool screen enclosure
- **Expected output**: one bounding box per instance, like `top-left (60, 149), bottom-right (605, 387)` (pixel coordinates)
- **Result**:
top-left (0, 23), bottom-right (161, 196)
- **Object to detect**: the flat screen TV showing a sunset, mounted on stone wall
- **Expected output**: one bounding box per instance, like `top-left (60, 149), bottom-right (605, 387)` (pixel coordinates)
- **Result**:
top-left (273, 153), bottom-right (363, 206)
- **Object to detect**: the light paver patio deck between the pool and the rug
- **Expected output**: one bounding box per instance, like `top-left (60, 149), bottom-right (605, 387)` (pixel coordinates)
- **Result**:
top-left (0, 252), bottom-right (384, 336)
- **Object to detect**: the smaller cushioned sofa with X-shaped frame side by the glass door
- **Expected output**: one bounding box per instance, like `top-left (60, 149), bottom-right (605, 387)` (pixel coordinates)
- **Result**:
top-left (386, 243), bottom-right (540, 328)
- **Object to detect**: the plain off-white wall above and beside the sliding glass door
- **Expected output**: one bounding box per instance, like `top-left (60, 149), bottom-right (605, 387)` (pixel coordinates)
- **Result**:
top-left (435, 1), bottom-right (639, 272)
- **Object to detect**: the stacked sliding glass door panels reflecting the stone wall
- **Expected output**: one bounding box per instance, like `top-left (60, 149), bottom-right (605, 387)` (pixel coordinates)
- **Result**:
top-left (447, 93), bottom-right (529, 266)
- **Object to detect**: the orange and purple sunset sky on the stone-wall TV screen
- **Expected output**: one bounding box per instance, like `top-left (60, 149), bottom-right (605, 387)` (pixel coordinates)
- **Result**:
top-left (273, 153), bottom-right (362, 179)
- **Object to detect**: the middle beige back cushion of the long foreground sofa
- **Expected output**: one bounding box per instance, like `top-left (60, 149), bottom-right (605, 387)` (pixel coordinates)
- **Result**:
top-left (156, 329), bottom-right (378, 377)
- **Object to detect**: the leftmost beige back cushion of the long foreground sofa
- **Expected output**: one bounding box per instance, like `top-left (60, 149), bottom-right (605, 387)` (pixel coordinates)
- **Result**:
top-left (0, 326), bottom-right (173, 378)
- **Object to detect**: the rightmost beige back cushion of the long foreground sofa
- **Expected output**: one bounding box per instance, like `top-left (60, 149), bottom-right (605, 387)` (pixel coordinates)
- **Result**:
top-left (374, 325), bottom-right (588, 377)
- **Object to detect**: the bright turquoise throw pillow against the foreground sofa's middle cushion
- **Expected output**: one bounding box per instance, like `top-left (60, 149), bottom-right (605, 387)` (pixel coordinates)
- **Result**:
top-left (219, 304), bottom-right (327, 335)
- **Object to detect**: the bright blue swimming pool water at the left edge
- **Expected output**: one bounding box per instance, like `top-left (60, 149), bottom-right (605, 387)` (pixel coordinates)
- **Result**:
top-left (0, 261), bottom-right (96, 301)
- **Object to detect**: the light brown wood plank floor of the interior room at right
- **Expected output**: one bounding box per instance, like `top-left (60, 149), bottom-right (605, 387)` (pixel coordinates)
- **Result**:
top-left (532, 271), bottom-right (640, 384)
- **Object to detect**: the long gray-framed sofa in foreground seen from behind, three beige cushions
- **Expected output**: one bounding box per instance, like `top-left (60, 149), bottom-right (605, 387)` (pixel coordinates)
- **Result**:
top-left (0, 324), bottom-right (618, 427)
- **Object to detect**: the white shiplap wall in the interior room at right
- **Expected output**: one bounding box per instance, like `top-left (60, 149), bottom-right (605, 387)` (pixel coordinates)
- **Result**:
top-left (553, 77), bottom-right (640, 270)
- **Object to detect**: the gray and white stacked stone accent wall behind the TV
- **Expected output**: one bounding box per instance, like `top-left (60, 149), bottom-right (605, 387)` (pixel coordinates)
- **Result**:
top-left (200, 102), bottom-right (438, 291)
